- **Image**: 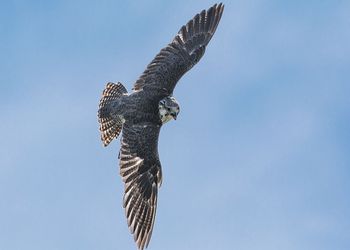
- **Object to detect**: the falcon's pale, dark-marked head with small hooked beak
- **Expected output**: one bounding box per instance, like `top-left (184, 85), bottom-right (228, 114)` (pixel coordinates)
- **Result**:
top-left (158, 96), bottom-right (180, 124)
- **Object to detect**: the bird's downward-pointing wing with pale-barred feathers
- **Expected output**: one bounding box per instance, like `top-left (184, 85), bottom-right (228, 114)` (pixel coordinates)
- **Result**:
top-left (119, 122), bottom-right (162, 250)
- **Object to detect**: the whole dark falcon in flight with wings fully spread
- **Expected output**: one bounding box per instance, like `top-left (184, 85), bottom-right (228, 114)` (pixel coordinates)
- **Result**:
top-left (98, 3), bottom-right (224, 250)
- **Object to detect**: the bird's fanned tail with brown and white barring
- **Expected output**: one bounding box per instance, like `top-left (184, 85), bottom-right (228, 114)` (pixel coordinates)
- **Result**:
top-left (98, 82), bottom-right (128, 147)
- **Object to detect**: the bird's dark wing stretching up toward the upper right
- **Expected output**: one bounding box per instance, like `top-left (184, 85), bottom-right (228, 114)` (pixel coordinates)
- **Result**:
top-left (133, 3), bottom-right (224, 94)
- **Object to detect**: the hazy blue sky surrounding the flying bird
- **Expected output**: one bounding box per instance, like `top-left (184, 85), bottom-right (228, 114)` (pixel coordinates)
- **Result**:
top-left (0, 0), bottom-right (350, 250)
